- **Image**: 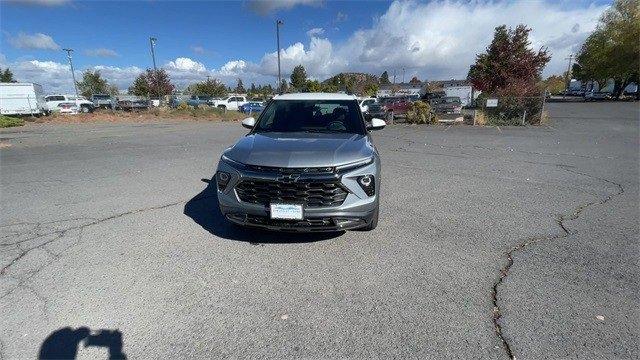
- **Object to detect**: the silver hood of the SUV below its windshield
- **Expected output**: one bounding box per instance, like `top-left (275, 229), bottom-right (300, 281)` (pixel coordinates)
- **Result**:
top-left (225, 132), bottom-right (374, 167)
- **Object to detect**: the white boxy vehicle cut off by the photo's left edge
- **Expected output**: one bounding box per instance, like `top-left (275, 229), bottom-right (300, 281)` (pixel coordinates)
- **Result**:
top-left (0, 83), bottom-right (49, 116)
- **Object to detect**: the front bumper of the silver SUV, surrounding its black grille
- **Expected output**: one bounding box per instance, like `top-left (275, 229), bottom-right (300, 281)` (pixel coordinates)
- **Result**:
top-left (214, 156), bottom-right (380, 232)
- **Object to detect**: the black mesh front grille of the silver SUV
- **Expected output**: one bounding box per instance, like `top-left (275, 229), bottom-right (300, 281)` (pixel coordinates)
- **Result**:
top-left (236, 179), bottom-right (348, 207)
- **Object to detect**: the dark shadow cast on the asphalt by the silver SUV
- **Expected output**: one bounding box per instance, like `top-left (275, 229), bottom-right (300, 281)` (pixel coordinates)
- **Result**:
top-left (184, 179), bottom-right (344, 245)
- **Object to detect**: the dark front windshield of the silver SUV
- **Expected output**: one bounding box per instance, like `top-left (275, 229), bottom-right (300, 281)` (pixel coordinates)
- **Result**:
top-left (254, 100), bottom-right (365, 134)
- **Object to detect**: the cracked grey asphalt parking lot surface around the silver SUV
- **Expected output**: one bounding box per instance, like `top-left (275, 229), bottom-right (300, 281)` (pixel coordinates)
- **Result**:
top-left (0, 102), bottom-right (640, 359)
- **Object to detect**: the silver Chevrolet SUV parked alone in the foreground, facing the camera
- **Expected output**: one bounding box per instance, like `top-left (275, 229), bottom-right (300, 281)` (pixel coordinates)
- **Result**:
top-left (215, 93), bottom-right (386, 231)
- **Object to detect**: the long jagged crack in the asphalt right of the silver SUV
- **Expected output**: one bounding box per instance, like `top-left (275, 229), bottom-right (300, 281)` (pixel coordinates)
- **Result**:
top-left (491, 164), bottom-right (624, 359)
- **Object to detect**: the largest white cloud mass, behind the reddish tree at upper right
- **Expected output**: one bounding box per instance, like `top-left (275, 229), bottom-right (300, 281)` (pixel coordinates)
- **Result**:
top-left (334, 1), bottom-right (607, 79)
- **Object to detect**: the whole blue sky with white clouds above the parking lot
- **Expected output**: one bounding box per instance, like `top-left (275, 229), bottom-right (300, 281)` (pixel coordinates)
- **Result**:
top-left (0, 0), bottom-right (609, 91)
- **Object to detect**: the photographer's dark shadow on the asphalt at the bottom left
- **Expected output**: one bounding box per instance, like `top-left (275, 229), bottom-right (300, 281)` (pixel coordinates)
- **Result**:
top-left (38, 327), bottom-right (127, 359)
